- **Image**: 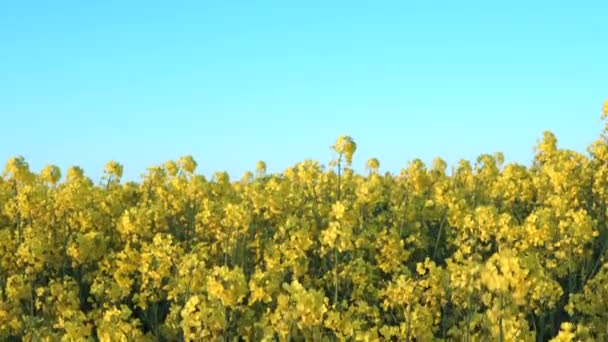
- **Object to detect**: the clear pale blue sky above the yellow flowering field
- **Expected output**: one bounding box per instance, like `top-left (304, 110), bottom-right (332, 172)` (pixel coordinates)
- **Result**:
top-left (0, 1), bottom-right (608, 180)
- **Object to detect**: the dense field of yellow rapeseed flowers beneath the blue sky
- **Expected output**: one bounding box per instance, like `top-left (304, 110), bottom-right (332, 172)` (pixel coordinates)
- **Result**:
top-left (0, 105), bottom-right (608, 341)
